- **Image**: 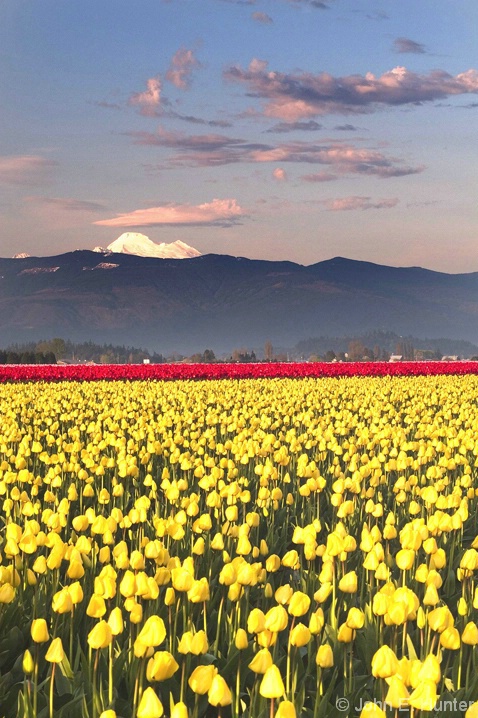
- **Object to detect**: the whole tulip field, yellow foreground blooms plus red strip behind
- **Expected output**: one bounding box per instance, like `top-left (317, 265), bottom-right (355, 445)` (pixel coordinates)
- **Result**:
top-left (0, 362), bottom-right (478, 718)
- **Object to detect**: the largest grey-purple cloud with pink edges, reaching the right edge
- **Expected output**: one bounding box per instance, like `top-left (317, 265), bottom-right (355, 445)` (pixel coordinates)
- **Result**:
top-left (224, 59), bottom-right (478, 122)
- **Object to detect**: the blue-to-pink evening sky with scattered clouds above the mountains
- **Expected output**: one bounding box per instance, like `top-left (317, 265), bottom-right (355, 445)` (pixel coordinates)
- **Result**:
top-left (0, 0), bottom-right (478, 273)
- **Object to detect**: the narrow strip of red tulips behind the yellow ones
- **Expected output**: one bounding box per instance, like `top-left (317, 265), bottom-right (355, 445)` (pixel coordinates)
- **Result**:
top-left (0, 361), bottom-right (478, 383)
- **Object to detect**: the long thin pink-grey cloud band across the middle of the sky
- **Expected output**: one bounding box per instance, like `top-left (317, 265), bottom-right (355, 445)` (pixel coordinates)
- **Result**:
top-left (132, 128), bottom-right (424, 178)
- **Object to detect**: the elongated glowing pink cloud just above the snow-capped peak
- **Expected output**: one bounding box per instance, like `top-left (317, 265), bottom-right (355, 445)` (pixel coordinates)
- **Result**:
top-left (94, 199), bottom-right (245, 227)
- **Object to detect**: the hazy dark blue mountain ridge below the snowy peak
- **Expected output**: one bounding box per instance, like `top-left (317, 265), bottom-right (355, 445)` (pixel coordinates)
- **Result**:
top-left (0, 250), bottom-right (478, 354)
